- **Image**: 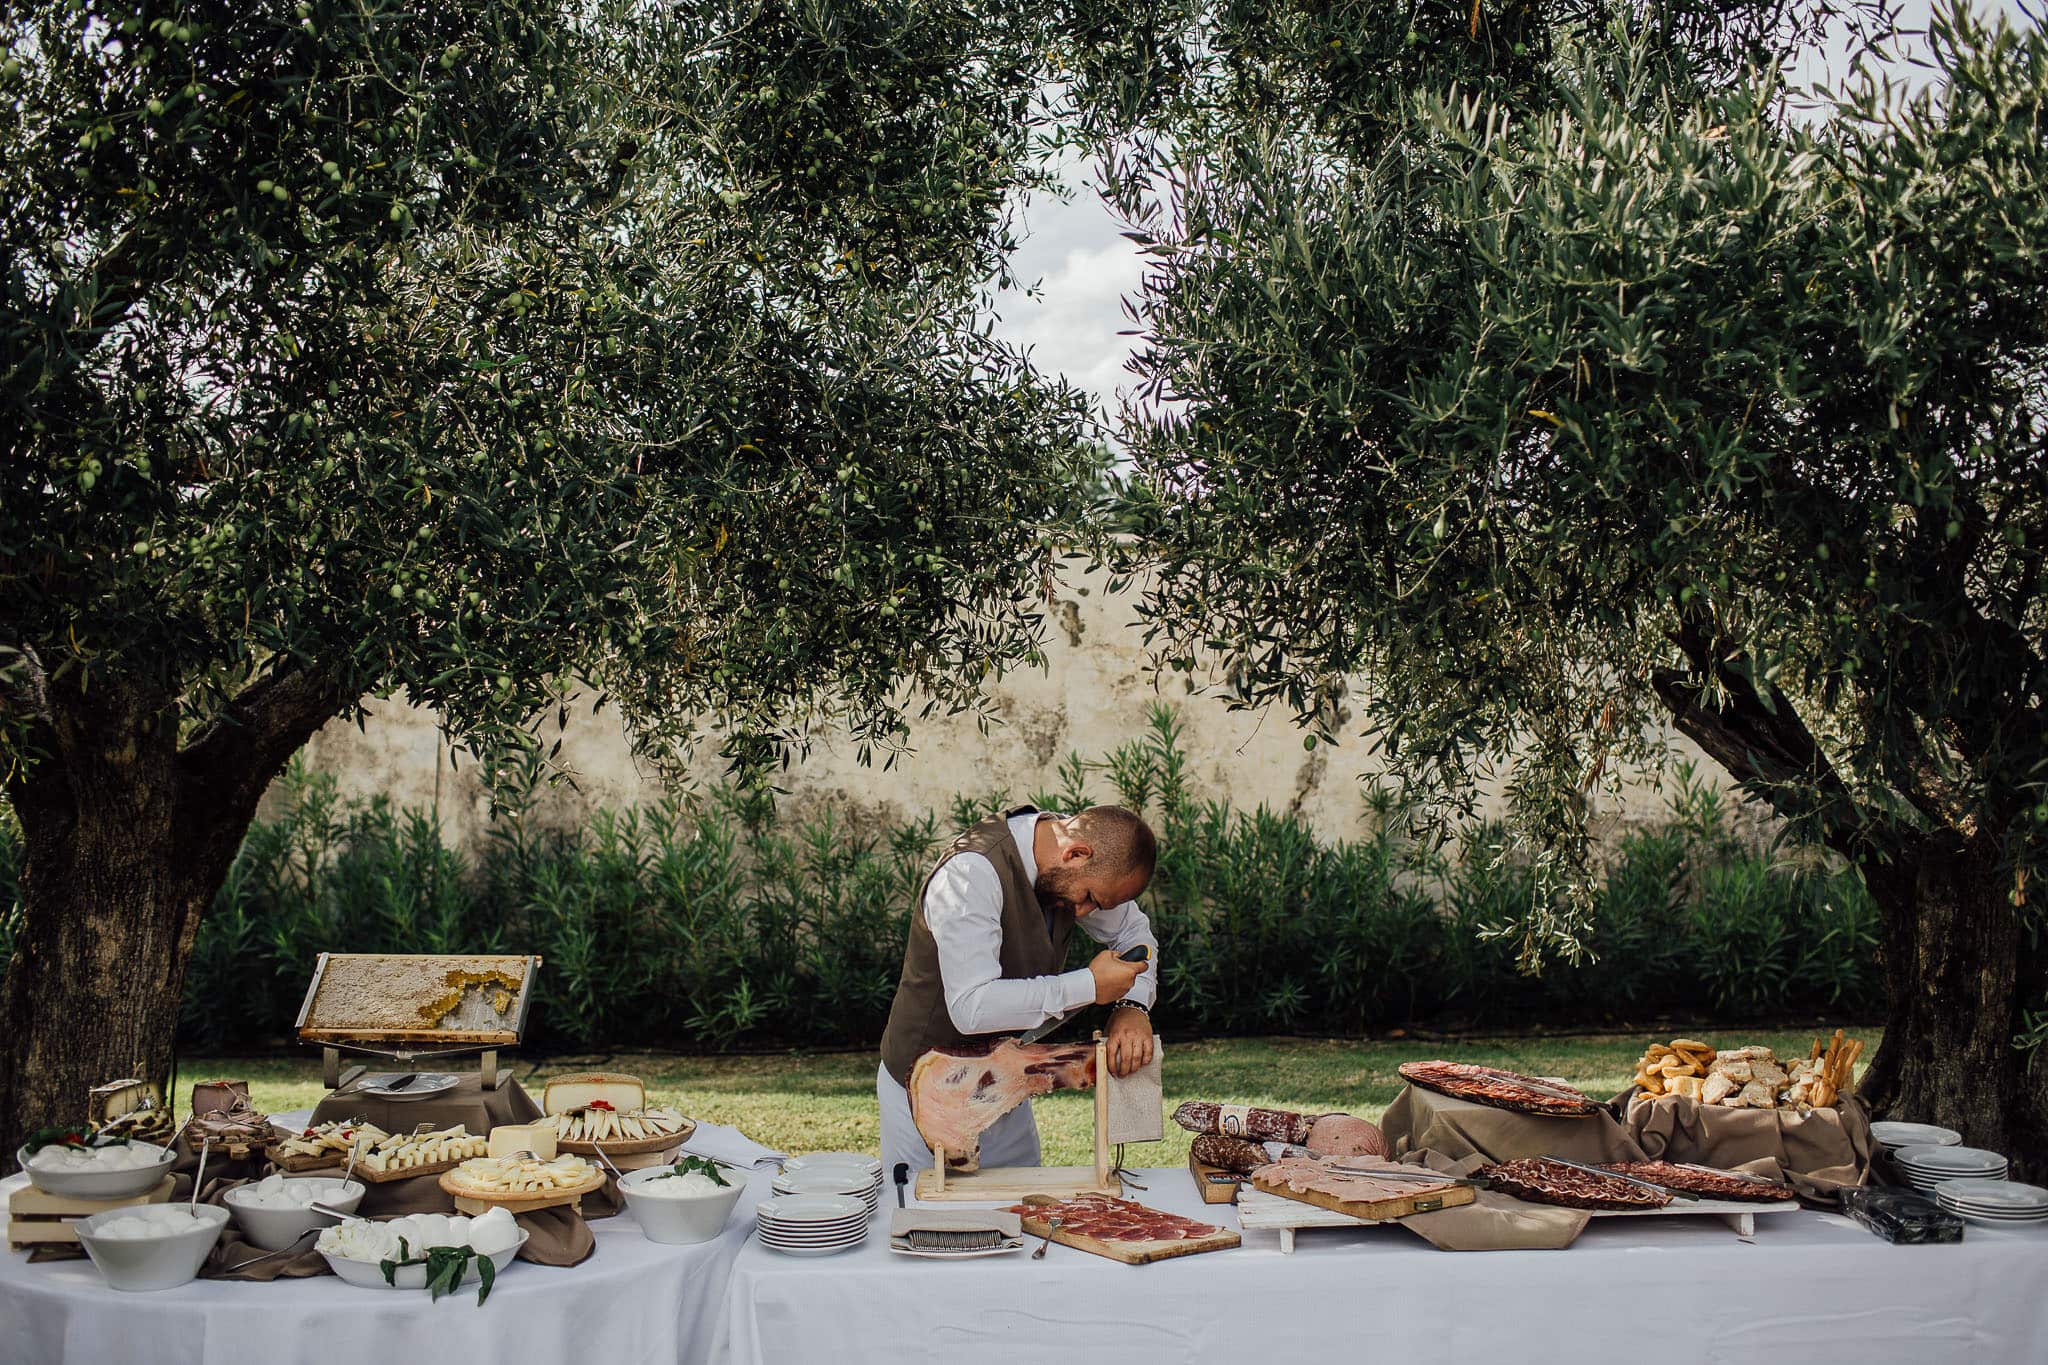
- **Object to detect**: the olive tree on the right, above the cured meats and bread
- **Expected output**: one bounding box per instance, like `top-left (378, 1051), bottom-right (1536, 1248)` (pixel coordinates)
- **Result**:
top-left (1081, 2), bottom-right (2048, 1152)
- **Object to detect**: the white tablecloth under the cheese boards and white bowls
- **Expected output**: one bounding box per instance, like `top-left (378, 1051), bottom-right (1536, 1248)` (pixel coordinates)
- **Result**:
top-left (0, 1171), bottom-right (772, 1365)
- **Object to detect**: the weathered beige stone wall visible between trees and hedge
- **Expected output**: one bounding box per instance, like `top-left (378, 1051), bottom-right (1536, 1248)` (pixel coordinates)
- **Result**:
top-left (307, 564), bottom-right (1714, 847)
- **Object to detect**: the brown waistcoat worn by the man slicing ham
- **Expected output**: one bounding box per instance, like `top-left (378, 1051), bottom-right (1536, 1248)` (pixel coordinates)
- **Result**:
top-left (883, 806), bottom-right (1073, 1085)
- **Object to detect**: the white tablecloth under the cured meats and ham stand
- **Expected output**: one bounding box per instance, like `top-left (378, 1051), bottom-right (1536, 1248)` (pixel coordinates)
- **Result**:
top-left (725, 1171), bottom-right (2048, 1365)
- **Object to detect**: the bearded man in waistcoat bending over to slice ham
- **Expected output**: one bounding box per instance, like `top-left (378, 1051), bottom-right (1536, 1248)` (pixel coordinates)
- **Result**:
top-left (874, 806), bottom-right (1159, 1171)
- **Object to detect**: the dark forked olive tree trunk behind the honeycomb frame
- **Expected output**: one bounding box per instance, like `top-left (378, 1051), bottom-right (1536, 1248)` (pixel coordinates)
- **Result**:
top-left (0, 673), bottom-right (338, 1171)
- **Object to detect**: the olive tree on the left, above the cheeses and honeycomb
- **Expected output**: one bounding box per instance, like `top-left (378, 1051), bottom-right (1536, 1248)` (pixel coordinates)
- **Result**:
top-left (0, 0), bottom-right (1098, 1150)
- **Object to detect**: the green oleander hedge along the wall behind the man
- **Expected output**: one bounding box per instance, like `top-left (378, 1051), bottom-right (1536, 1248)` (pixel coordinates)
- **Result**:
top-left (0, 708), bottom-right (1880, 1050)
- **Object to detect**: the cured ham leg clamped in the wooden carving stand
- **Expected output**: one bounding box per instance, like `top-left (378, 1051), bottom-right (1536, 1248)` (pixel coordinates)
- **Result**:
top-left (909, 1038), bottom-right (1096, 1171)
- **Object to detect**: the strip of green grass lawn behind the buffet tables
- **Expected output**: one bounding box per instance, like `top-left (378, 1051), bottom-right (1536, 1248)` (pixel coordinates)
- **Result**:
top-left (174, 1029), bottom-right (1878, 1166)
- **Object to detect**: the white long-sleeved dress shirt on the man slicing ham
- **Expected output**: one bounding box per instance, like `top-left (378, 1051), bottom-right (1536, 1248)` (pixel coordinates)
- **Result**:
top-left (924, 812), bottom-right (1159, 1033)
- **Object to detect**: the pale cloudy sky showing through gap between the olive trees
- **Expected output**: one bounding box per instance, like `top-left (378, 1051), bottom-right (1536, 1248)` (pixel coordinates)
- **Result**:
top-left (997, 0), bottom-right (2025, 421)
